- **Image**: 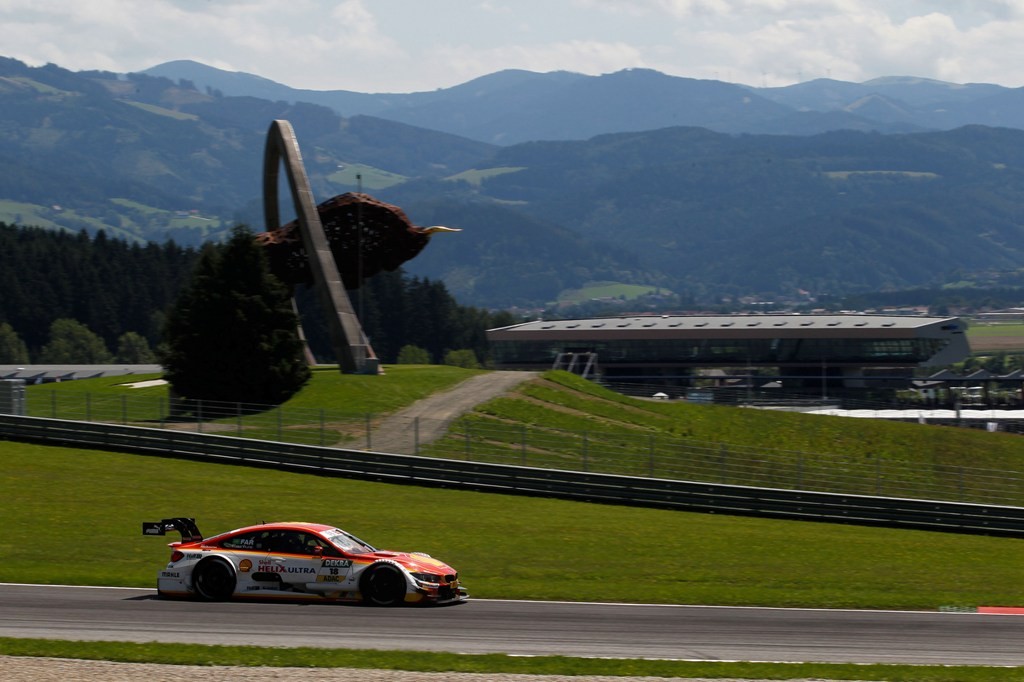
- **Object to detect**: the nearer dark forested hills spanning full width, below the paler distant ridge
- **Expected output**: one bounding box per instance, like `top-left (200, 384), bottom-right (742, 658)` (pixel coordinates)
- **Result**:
top-left (0, 59), bottom-right (1024, 309)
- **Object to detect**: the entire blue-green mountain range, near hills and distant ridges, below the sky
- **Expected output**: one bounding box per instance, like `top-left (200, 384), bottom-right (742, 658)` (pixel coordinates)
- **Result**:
top-left (0, 58), bottom-right (1024, 307)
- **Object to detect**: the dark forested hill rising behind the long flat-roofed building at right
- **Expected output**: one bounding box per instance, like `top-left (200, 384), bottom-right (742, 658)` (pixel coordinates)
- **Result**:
top-left (473, 126), bottom-right (1024, 300)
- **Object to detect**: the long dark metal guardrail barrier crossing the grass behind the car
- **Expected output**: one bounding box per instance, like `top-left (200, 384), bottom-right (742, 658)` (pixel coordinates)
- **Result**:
top-left (6, 415), bottom-right (1024, 537)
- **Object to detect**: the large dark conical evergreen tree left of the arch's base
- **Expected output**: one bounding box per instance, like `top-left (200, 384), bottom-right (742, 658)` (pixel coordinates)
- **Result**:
top-left (161, 225), bottom-right (310, 404)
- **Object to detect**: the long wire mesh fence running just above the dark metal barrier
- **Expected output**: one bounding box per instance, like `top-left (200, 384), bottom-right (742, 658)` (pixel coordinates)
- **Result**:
top-left (14, 391), bottom-right (1024, 506)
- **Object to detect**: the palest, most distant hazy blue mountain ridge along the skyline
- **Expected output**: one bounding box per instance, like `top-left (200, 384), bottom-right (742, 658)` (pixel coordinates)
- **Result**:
top-left (143, 60), bottom-right (1024, 144)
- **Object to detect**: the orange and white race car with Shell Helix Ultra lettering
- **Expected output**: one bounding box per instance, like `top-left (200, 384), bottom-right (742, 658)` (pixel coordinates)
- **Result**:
top-left (142, 517), bottom-right (469, 606)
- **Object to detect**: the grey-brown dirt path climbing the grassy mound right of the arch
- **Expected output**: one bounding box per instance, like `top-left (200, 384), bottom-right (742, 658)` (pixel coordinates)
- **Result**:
top-left (367, 371), bottom-right (541, 455)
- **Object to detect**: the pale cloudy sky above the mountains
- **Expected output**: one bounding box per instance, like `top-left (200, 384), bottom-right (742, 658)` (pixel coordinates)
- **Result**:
top-left (0, 0), bottom-right (1024, 92)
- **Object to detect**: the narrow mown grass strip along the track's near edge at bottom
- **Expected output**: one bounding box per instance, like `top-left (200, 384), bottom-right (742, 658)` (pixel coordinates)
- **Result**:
top-left (0, 637), bottom-right (1024, 682)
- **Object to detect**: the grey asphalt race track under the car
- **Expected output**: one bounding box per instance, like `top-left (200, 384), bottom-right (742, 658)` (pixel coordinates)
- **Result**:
top-left (6, 584), bottom-right (1024, 666)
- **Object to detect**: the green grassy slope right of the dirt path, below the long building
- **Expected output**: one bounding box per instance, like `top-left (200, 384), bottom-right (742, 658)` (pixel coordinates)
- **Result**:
top-left (421, 372), bottom-right (1024, 505)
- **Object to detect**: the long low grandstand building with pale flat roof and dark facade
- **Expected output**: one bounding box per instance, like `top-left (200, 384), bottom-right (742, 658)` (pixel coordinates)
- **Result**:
top-left (487, 314), bottom-right (971, 388)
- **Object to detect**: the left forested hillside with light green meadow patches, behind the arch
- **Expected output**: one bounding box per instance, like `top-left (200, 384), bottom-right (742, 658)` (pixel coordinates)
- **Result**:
top-left (0, 57), bottom-right (490, 246)
